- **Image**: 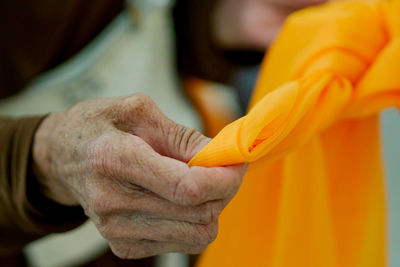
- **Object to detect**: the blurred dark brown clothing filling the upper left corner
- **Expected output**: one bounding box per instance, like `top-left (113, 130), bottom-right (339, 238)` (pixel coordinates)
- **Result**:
top-left (0, 0), bottom-right (124, 98)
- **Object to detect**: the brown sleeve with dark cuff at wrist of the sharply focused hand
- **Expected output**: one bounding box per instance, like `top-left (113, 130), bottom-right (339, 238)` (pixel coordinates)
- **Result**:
top-left (0, 116), bottom-right (86, 255)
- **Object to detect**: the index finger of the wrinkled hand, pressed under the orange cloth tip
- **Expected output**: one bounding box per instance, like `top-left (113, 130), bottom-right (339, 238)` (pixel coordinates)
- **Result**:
top-left (96, 132), bottom-right (246, 206)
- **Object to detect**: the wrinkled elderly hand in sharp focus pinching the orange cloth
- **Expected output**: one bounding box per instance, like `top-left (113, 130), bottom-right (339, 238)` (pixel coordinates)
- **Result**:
top-left (33, 94), bottom-right (245, 258)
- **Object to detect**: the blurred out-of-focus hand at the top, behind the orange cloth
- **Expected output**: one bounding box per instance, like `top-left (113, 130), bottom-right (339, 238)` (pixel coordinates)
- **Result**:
top-left (213, 0), bottom-right (327, 50)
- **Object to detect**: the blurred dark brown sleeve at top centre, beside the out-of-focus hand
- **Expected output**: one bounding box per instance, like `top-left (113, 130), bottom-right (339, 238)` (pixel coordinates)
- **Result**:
top-left (173, 0), bottom-right (264, 83)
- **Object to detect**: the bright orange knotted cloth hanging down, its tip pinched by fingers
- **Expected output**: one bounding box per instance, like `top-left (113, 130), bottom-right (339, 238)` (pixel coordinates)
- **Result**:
top-left (189, 0), bottom-right (400, 267)
